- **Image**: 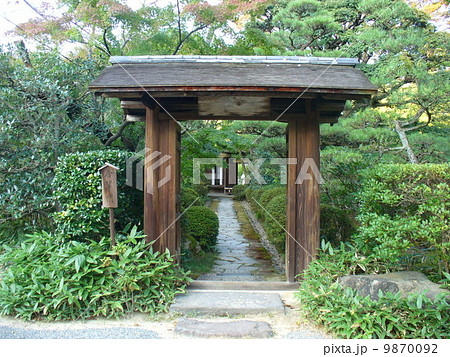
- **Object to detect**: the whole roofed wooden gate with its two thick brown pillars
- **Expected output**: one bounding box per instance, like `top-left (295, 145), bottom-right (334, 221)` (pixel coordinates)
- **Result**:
top-left (89, 56), bottom-right (376, 282)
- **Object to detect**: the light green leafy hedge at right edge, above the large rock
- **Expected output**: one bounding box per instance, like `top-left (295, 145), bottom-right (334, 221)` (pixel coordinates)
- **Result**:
top-left (355, 164), bottom-right (450, 279)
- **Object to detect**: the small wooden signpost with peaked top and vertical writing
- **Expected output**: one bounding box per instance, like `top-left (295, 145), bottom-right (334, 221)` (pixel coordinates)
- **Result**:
top-left (98, 163), bottom-right (119, 246)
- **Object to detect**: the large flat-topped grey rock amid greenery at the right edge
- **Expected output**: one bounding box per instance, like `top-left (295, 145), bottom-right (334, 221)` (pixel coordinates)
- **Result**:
top-left (339, 271), bottom-right (450, 300)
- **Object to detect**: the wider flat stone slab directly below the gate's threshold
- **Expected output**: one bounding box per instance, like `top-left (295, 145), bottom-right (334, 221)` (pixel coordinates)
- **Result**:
top-left (170, 291), bottom-right (284, 316)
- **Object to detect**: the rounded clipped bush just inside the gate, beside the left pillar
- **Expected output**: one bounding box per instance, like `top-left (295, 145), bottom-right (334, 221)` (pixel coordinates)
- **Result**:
top-left (185, 206), bottom-right (219, 251)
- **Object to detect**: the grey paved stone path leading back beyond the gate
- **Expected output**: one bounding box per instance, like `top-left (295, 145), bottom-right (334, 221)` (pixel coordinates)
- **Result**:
top-left (198, 197), bottom-right (284, 281)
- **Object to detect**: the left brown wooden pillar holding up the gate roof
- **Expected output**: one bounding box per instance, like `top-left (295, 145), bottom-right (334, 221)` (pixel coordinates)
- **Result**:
top-left (144, 105), bottom-right (181, 259)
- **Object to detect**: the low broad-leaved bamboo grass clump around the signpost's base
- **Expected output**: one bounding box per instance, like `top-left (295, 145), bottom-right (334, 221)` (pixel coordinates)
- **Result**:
top-left (0, 228), bottom-right (188, 320)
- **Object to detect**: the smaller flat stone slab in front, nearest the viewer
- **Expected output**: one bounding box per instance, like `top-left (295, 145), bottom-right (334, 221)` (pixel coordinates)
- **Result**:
top-left (175, 318), bottom-right (273, 338)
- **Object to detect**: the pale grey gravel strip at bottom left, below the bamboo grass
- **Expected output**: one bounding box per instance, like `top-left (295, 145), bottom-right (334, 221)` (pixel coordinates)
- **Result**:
top-left (0, 325), bottom-right (159, 339)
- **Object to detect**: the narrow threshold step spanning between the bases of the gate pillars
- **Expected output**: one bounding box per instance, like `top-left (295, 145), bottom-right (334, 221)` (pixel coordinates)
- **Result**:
top-left (188, 280), bottom-right (300, 291)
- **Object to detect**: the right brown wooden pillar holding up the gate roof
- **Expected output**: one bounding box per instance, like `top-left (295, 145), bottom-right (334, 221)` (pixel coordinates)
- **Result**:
top-left (286, 112), bottom-right (320, 282)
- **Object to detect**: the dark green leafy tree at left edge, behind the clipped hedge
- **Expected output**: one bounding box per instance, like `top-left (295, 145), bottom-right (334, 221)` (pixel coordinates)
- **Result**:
top-left (0, 49), bottom-right (131, 236)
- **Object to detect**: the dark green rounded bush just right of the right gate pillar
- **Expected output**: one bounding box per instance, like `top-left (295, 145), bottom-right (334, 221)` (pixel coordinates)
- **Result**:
top-left (320, 204), bottom-right (356, 245)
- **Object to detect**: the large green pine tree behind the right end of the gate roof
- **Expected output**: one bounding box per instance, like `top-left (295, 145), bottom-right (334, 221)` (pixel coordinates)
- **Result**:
top-left (235, 0), bottom-right (449, 163)
